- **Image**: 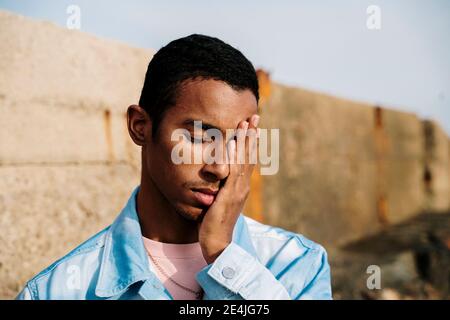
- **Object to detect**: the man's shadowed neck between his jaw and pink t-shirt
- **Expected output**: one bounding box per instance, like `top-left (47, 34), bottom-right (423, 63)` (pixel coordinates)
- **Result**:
top-left (136, 170), bottom-right (198, 244)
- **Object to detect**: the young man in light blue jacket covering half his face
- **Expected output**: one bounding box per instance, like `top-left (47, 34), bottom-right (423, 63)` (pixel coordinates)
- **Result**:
top-left (17, 35), bottom-right (331, 299)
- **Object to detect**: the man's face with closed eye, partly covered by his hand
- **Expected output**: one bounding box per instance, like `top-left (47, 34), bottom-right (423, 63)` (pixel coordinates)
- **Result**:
top-left (143, 80), bottom-right (257, 220)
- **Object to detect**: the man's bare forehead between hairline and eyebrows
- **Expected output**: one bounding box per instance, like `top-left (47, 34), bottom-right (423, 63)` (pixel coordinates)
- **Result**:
top-left (167, 80), bottom-right (257, 130)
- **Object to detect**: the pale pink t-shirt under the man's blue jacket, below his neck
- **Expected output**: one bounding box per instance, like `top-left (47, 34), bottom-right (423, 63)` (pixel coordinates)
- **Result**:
top-left (143, 237), bottom-right (207, 300)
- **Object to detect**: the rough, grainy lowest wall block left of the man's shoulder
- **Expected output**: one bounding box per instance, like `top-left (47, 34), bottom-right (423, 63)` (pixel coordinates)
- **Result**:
top-left (0, 164), bottom-right (139, 299)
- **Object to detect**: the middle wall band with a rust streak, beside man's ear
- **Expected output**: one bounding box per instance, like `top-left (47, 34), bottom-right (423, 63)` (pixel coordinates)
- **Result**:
top-left (0, 101), bottom-right (139, 165)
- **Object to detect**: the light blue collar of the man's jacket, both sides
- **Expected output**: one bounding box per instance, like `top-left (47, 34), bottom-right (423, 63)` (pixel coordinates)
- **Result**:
top-left (95, 187), bottom-right (258, 297)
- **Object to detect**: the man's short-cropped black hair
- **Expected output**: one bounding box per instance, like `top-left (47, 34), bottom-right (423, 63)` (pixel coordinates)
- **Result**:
top-left (139, 34), bottom-right (259, 135)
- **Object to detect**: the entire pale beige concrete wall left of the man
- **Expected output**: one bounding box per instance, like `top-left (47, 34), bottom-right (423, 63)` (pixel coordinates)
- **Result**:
top-left (0, 11), bottom-right (153, 298)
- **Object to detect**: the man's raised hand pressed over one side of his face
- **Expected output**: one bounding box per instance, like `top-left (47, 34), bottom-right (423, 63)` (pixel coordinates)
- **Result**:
top-left (198, 114), bottom-right (259, 264)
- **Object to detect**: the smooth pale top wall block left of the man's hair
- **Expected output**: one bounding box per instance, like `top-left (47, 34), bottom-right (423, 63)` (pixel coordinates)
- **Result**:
top-left (0, 11), bottom-right (154, 111)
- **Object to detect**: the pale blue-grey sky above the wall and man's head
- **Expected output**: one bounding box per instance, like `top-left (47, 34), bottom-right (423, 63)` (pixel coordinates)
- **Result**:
top-left (0, 0), bottom-right (450, 134)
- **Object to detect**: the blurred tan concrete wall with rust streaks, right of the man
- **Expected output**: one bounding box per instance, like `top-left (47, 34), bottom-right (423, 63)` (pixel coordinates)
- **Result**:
top-left (261, 84), bottom-right (450, 247)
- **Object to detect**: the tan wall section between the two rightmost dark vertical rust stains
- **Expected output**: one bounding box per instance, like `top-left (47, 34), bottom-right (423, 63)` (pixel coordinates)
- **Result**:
top-left (379, 109), bottom-right (425, 224)
